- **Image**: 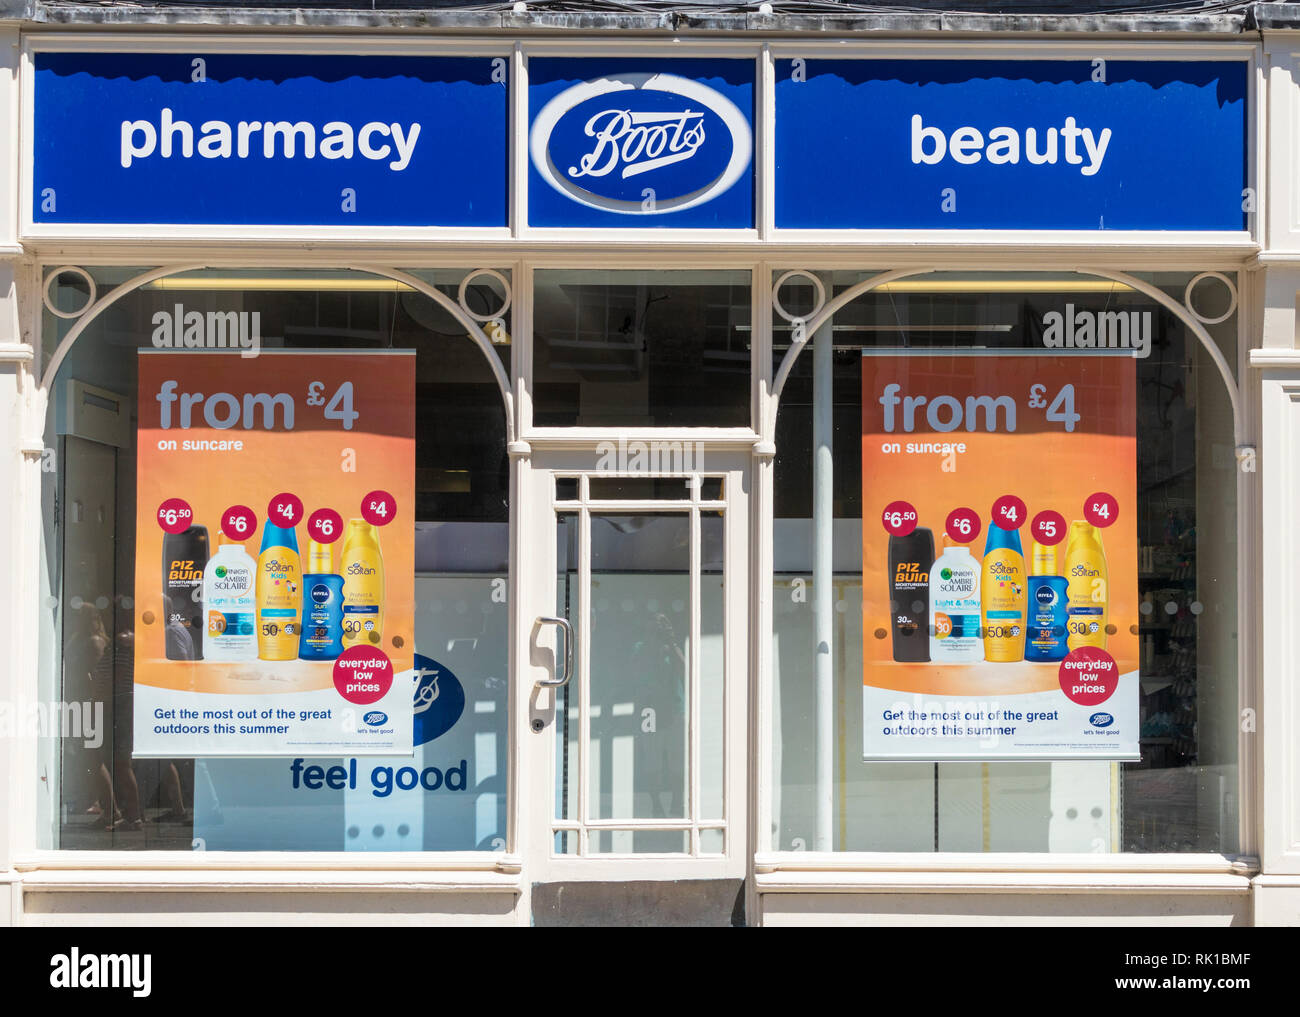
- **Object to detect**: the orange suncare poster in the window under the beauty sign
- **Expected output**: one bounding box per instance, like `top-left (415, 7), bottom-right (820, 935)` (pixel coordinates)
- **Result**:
top-left (862, 350), bottom-right (1139, 759)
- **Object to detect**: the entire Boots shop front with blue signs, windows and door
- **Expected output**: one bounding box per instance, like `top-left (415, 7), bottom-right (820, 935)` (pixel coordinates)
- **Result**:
top-left (0, 19), bottom-right (1300, 926)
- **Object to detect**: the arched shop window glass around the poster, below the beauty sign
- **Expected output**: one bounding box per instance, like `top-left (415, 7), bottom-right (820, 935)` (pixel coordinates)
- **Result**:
top-left (770, 273), bottom-right (1239, 854)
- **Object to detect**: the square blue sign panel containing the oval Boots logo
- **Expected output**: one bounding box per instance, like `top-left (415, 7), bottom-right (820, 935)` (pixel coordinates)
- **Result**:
top-left (528, 59), bottom-right (754, 229)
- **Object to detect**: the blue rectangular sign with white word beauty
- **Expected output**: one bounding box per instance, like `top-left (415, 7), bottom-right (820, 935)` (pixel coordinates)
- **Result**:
top-left (776, 60), bottom-right (1248, 230)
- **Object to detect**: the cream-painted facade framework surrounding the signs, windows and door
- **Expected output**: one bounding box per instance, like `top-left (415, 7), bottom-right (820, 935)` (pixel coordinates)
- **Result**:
top-left (0, 9), bottom-right (1300, 926)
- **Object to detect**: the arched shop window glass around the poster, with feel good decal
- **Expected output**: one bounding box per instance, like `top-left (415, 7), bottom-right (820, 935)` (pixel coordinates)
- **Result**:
top-left (38, 268), bottom-right (511, 852)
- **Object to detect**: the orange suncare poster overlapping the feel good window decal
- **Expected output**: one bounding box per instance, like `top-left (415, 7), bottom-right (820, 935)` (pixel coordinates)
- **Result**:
top-left (135, 351), bottom-right (415, 757)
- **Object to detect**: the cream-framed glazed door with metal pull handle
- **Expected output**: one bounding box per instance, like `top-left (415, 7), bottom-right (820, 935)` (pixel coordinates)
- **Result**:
top-left (523, 453), bottom-right (749, 880)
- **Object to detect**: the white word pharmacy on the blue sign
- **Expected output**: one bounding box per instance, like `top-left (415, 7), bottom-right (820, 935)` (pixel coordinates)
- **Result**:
top-left (121, 107), bottom-right (420, 173)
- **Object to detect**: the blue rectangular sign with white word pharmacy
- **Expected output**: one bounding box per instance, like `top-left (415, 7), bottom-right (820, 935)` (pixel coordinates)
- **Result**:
top-left (31, 52), bottom-right (510, 228)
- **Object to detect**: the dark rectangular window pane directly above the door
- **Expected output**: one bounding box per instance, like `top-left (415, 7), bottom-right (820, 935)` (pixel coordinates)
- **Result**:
top-left (533, 269), bottom-right (750, 427)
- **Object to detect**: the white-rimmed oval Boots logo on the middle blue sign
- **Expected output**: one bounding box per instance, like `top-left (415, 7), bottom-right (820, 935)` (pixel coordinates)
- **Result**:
top-left (529, 73), bottom-right (754, 216)
